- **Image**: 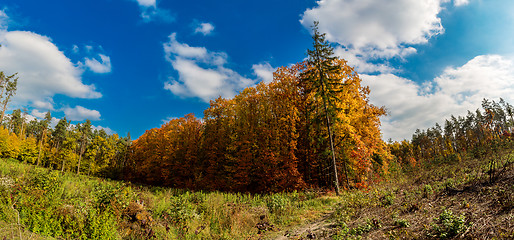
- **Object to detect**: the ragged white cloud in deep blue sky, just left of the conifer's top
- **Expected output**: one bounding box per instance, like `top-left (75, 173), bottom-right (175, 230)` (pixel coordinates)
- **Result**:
top-left (163, 33), bottom-right (255, 102)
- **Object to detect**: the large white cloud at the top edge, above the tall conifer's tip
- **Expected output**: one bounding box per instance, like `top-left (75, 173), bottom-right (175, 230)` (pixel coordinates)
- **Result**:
top-left (300, 0), bottom-right (444, 57)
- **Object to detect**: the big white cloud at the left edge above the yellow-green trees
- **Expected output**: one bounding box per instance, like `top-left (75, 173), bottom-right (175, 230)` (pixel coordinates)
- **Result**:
top-left (0, 31), bottom-right (102, 109)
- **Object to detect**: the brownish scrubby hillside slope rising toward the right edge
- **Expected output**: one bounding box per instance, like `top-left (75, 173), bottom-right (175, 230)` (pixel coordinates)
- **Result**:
top-left (270, 152), bottom-right (514, 239)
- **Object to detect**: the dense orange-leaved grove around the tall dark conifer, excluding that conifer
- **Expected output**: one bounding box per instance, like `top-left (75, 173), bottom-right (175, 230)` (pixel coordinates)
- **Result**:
top-left (125, 59), bottom-right (389, 192)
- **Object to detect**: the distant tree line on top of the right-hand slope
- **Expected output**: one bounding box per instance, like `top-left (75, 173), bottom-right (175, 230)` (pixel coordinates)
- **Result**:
top-left (389, 98), bottom-right (514, 169)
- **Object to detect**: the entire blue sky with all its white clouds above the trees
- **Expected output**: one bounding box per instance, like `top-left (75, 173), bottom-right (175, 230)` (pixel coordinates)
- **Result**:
top-left (0, 0), bottom-right (514, 140)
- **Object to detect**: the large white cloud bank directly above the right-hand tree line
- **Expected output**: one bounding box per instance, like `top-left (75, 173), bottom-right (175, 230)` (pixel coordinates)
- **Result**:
top-left (361, 55), bottom-right (514, 140)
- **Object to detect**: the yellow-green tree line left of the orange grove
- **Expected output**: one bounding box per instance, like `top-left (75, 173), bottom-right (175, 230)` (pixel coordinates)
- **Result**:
top-left (0, 109), bottom-right (131, 178)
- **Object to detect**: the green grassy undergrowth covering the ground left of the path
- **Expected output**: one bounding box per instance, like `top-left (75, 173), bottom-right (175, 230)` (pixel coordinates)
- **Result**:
top-left (0, 159), bottom-right (336, 239)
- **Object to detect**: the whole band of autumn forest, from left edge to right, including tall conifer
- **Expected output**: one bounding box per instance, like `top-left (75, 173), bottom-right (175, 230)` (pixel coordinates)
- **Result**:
top-left (0, 25), bottom-right (514, 193)
